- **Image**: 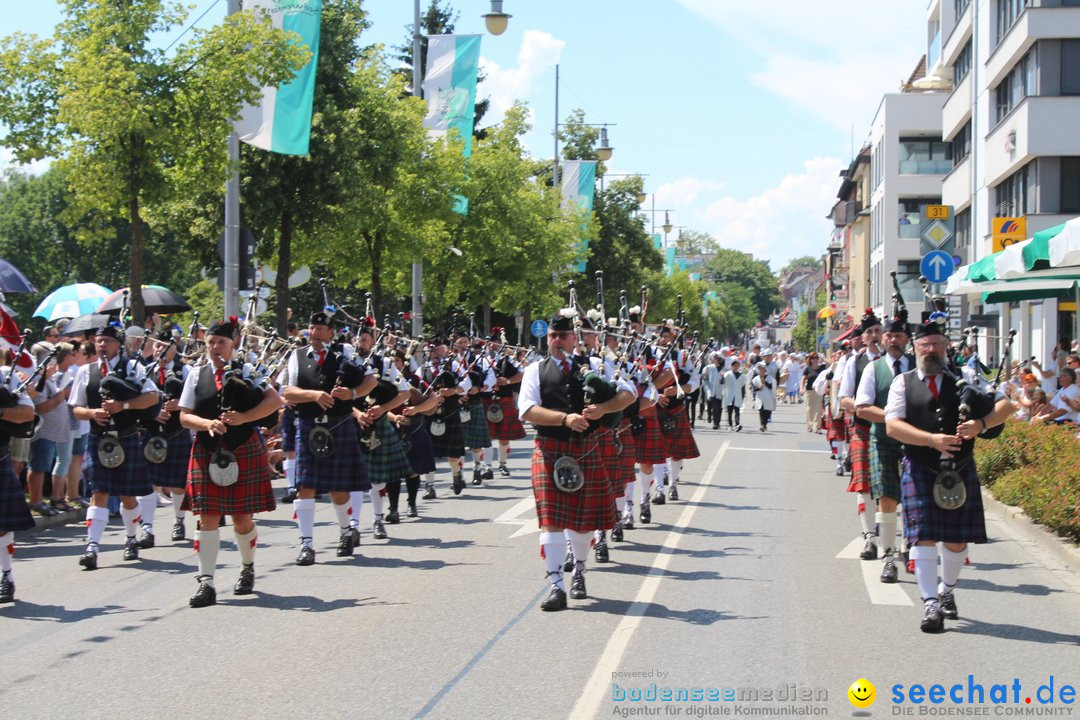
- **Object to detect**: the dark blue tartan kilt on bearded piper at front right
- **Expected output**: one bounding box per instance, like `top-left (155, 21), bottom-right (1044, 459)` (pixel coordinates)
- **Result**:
top-left (901, 458), bottom-right (986, 545)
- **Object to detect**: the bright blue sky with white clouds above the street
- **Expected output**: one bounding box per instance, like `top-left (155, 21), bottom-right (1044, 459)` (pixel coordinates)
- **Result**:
top-left (0, 0), bottom-right (927, 268)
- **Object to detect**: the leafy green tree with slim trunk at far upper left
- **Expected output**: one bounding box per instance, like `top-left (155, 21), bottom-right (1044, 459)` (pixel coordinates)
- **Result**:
top-left (0, 0), bottom-right (311, 323)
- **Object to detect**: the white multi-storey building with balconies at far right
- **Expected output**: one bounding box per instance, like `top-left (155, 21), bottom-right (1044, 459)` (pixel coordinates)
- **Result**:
top-left (927, 0), bottom-right (1080, 358)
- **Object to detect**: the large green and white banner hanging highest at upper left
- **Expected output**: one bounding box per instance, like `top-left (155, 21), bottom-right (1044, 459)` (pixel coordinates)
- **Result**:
top-left (237, 0), bottom-right (323, 155)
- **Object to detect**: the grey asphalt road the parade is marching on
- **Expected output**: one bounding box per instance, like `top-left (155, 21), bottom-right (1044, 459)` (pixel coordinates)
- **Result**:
top-left (0, 406), bottom-right (1080, 720)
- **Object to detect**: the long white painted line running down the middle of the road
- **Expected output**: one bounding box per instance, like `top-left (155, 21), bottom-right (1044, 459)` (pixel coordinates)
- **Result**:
top-left (569, 439), bottom-right (731, 718)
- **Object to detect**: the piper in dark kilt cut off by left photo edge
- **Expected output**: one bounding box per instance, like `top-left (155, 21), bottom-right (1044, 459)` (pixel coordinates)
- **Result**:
top-left (0, 362), bottom-right (35, 602)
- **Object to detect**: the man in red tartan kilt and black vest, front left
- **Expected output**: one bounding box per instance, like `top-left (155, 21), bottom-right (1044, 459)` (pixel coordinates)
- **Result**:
top-left (178, 323), bottom-right (281, 608)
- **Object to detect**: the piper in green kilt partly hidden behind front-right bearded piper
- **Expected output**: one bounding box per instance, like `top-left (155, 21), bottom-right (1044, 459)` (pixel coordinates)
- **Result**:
top-left (855, 311), bottom-right (915, 583)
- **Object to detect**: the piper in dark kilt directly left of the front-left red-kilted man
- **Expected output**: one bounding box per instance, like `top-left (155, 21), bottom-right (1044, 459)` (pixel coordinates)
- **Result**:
top-left (68, 325), bottom-right (159, 570)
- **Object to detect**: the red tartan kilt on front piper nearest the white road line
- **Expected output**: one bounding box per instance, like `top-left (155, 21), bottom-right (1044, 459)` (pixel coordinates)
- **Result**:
top-left (532, 435), bottom-right (622, 532)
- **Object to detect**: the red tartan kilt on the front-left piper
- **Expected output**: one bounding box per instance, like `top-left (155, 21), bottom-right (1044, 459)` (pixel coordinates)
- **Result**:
top-left (187, 431), bottom-right (275, 515)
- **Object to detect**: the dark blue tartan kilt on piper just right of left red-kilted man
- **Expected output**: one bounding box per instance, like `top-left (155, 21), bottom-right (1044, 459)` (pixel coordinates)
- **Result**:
top-left (296, 415), bottom-right (372, 492)
